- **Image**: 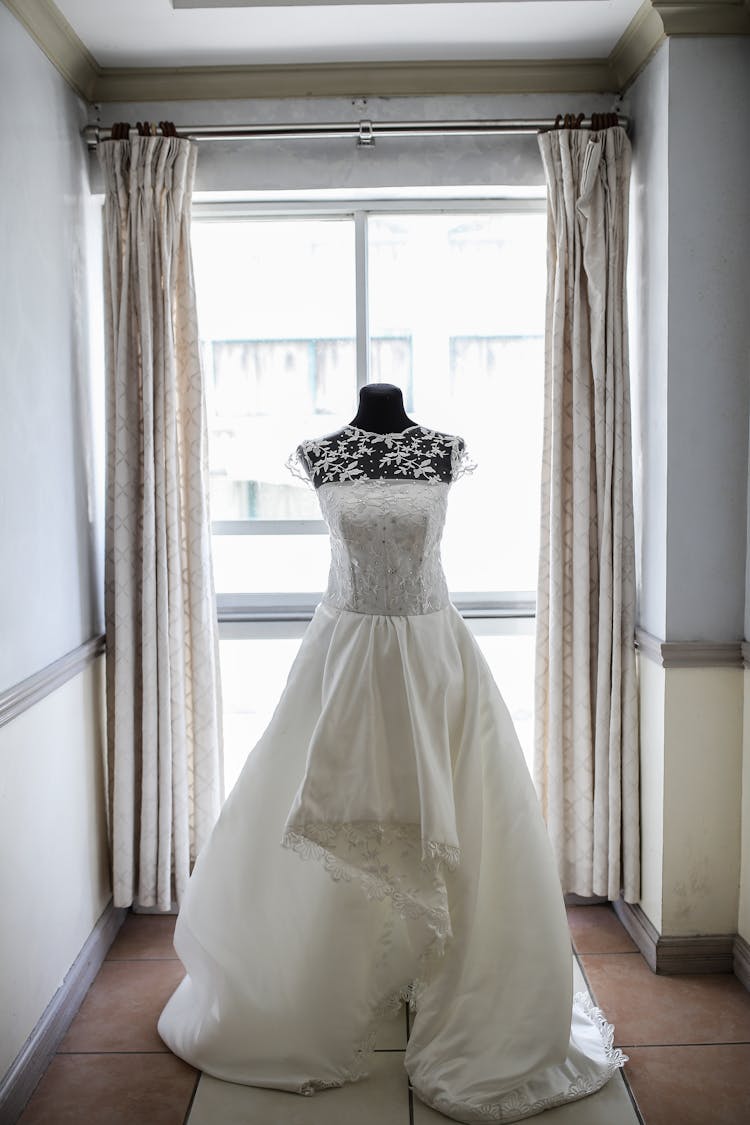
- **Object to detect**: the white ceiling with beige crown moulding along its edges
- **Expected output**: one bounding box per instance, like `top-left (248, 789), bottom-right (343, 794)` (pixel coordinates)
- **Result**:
top-left (8, 0), bottom-right (750, 105)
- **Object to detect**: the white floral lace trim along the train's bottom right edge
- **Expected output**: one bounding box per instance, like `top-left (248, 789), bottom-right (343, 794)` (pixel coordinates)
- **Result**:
top-left (414, 992), bottom-right (627, 1123)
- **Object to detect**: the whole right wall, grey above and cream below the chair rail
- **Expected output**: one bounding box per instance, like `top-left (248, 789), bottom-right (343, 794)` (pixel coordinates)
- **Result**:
top-left (629, 38), bottom-right (750, 935)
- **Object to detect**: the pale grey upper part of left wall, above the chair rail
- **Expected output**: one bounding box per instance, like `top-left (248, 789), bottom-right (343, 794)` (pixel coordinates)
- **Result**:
top-left (0, 5), bottom-right (102, 691)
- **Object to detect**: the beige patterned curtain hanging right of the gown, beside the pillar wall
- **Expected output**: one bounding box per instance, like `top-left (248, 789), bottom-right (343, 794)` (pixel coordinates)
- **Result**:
top-left (534, 127), bottom-right (640, 902)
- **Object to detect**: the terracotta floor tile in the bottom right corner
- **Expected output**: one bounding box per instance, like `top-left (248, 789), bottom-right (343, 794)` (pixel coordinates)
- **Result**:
top-left (627, 1044), bottom-right (750, 1125)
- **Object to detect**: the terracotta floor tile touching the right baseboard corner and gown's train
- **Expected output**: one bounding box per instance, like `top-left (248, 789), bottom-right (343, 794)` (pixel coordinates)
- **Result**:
top-left (580, 953), bottom-right (750, 1046)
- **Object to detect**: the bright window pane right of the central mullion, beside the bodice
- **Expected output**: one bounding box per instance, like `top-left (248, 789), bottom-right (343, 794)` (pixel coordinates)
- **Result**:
top-left (368, 213), bottom-right (546, 593)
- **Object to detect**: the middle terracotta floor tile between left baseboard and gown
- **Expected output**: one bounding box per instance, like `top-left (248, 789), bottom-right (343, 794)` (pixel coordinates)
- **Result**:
top-left (60, 961), bottom-right (184, 1053)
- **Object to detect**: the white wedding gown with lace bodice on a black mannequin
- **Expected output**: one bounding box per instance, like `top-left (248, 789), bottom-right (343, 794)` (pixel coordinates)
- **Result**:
top-left (159, 426), bottom-right (625, 1122)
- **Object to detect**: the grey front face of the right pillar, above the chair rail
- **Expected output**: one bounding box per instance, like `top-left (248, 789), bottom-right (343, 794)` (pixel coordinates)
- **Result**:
top-left (665, 38), bottom-right (750, 641)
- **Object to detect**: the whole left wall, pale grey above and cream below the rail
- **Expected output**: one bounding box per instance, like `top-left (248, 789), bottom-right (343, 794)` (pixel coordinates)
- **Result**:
top-left (0, 5), bottom-right (110, 1079)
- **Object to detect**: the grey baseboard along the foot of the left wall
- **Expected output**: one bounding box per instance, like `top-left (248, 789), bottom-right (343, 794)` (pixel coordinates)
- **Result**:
top-left (0, 900), bottom-right (127, 1125)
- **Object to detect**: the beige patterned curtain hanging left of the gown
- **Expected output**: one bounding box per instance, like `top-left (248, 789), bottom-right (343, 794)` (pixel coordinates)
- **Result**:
top-left (98, 128), bottom-right (222, 910)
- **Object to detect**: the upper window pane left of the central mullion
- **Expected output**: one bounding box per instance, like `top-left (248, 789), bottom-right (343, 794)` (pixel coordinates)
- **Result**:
top-left (192, 218), bottom-right (356, 522)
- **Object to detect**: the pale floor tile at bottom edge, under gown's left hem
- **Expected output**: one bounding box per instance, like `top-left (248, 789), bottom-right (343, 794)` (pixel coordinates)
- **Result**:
top-left (188, 1052), bottom-right (411, 1125)
